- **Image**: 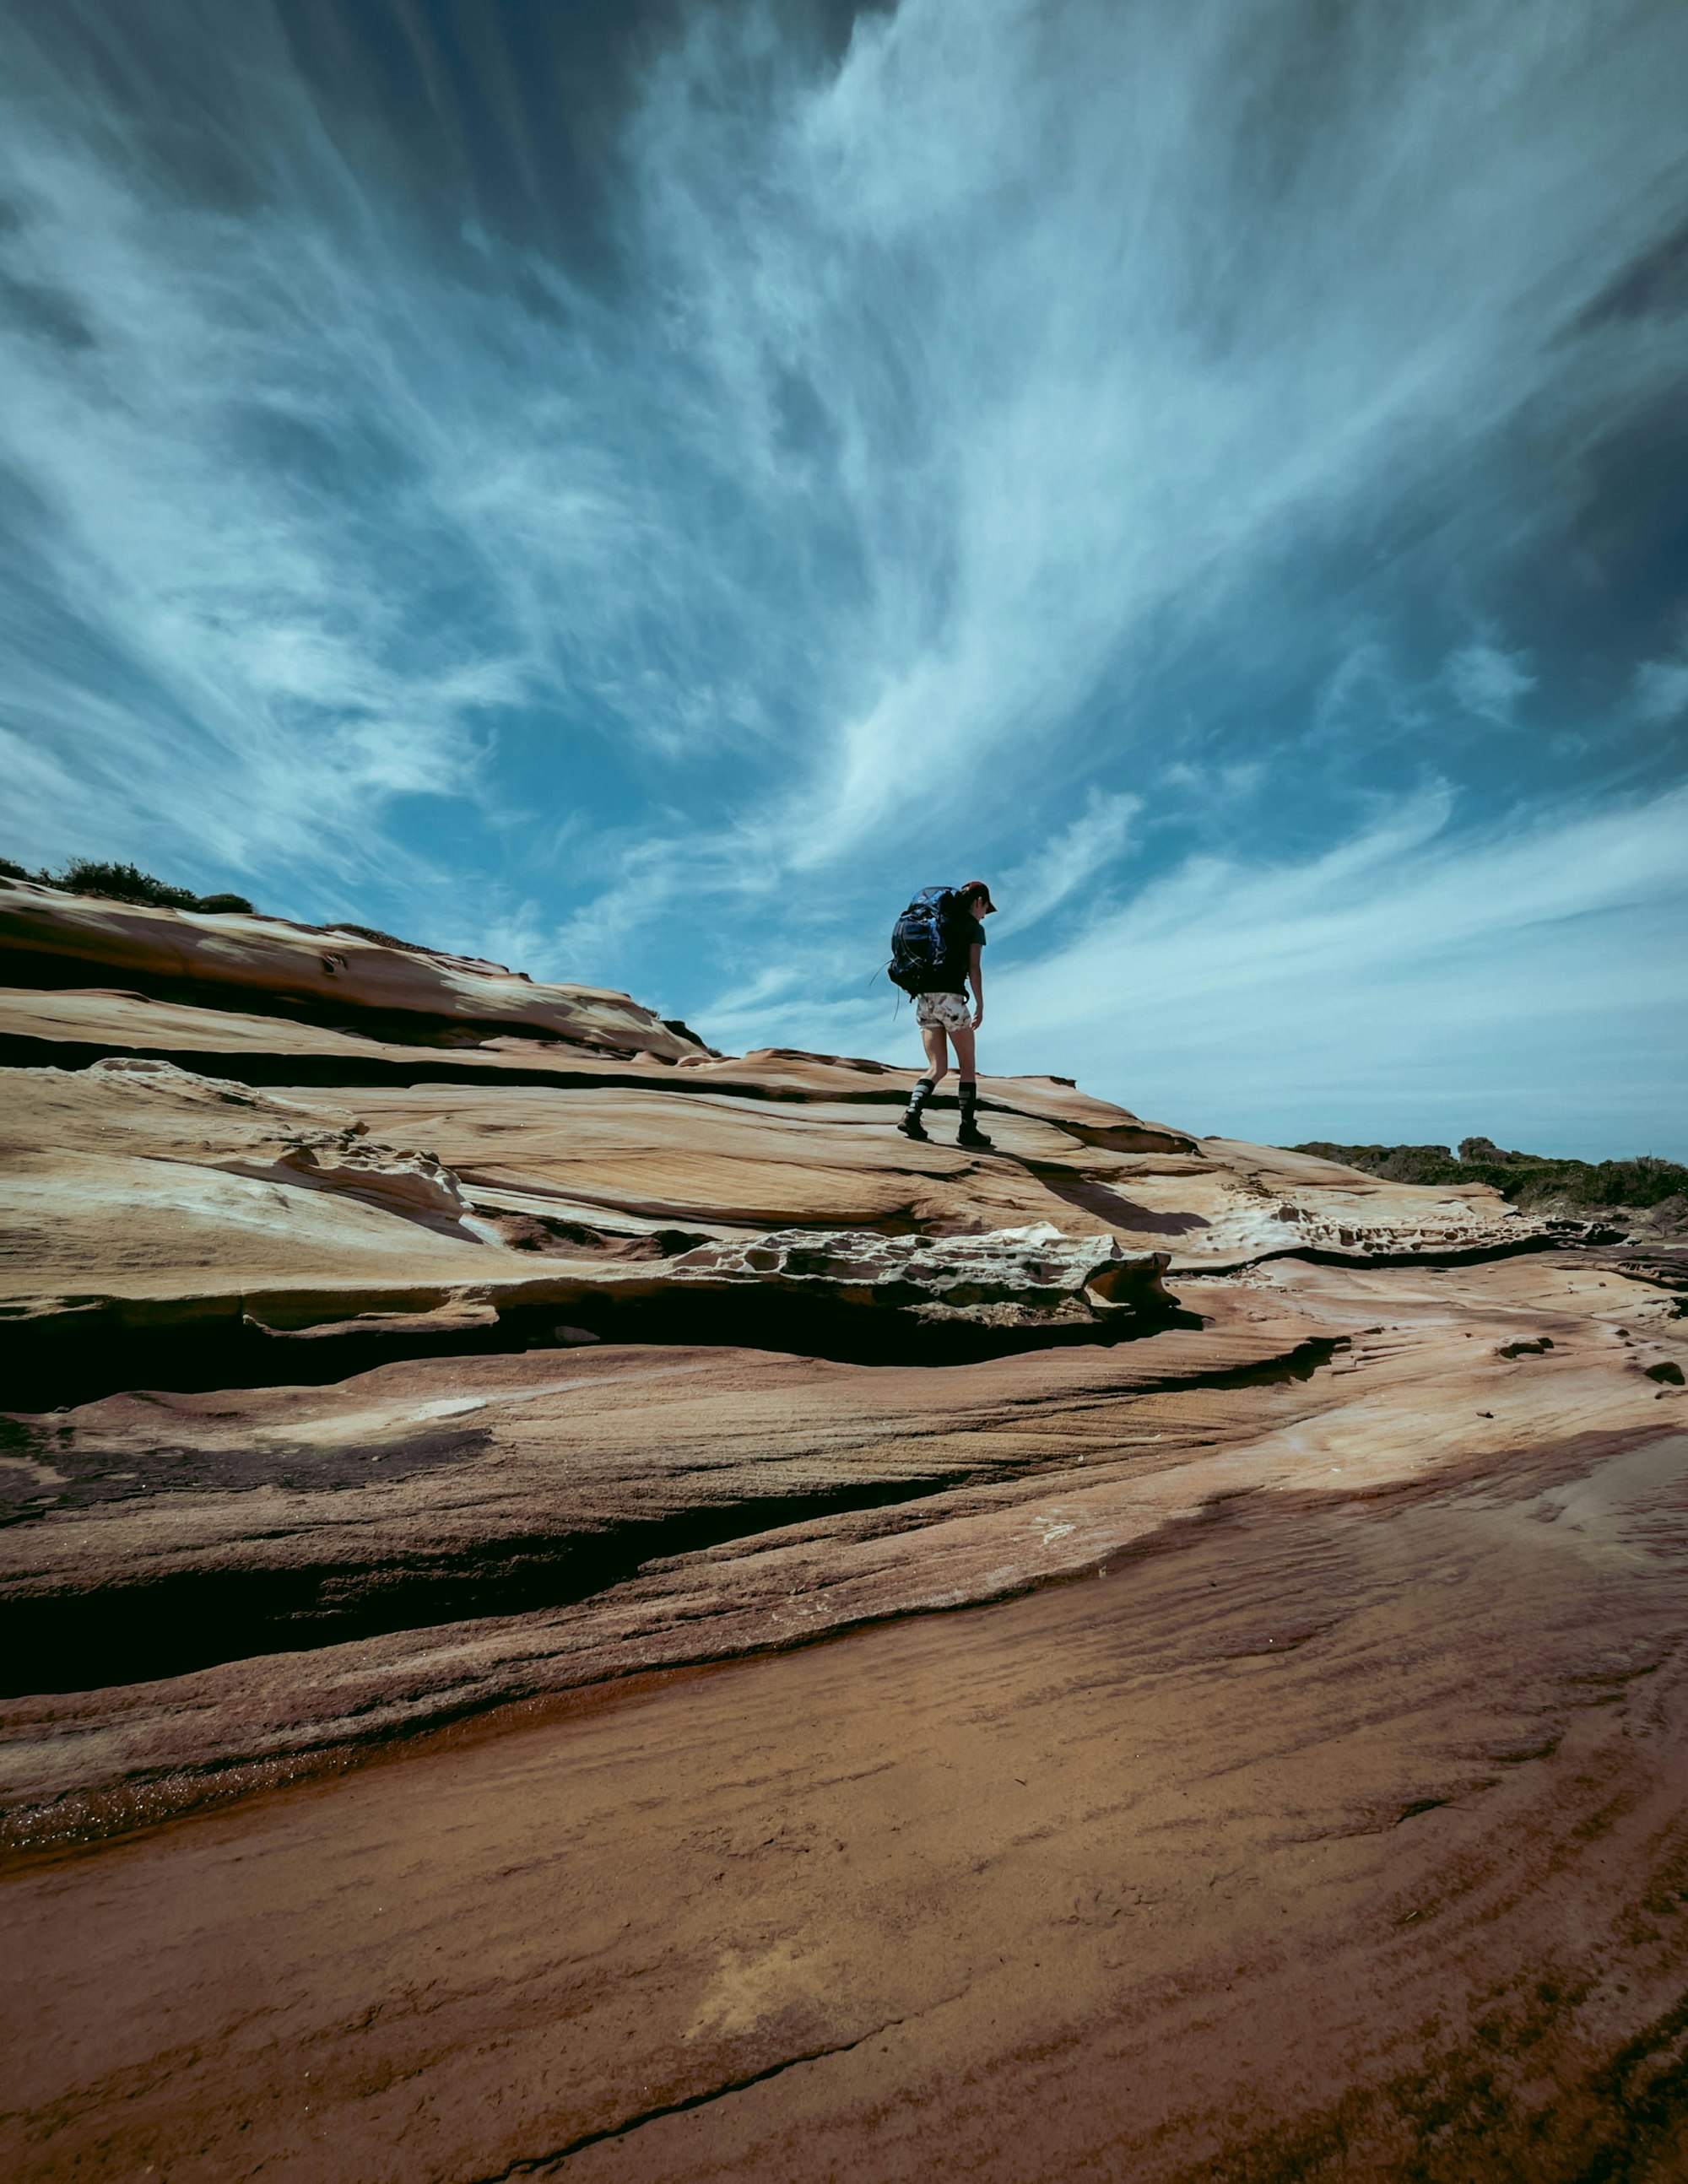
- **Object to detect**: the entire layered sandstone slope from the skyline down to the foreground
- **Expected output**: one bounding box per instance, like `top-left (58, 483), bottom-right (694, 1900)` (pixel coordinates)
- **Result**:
top-left (0, 908), bottom-right (1688, 2180)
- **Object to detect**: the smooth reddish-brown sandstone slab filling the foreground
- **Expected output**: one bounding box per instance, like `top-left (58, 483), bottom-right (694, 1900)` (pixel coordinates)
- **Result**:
top-left (0, 1397), bottom-right (1684, 2184)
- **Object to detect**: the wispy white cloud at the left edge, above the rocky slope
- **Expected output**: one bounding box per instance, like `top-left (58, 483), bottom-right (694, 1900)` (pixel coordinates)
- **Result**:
top-left (0, 100), bottom-right (513, 865)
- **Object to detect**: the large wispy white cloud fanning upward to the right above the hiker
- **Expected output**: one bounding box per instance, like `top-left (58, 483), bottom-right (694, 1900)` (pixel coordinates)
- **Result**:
top-left (619, 0), bottom-right (1681, 872)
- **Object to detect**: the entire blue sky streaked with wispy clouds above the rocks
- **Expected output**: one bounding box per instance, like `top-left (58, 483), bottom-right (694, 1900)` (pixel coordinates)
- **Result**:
top-left (0, 0), bottom-right (1688, 1158)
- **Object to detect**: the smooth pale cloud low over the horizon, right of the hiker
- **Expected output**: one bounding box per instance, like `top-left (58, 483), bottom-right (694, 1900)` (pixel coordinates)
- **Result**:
top-left (992, 791), bottom-right (1688, 1158)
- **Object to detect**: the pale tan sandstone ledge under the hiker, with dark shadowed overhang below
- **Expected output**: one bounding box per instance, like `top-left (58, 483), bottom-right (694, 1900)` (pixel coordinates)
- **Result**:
top-left (0, 1018), bottom-right (1544, 1408)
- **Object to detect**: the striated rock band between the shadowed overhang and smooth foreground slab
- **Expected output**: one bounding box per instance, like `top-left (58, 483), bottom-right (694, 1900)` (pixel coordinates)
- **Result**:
top-left (0, 1260), bottom-right (1688, 1839)
